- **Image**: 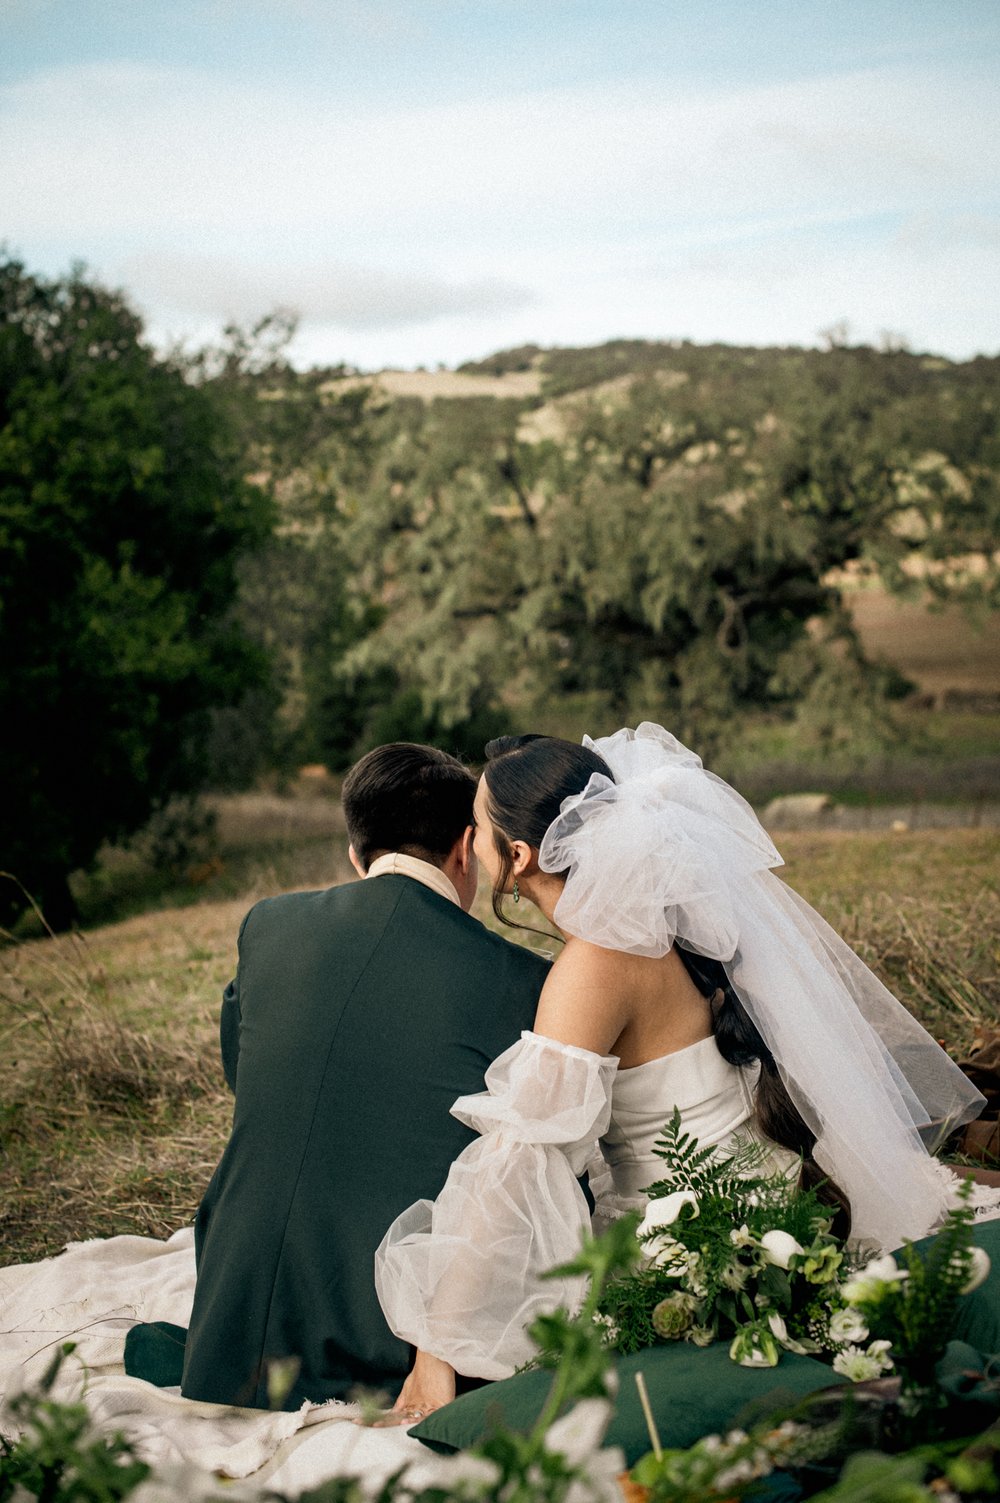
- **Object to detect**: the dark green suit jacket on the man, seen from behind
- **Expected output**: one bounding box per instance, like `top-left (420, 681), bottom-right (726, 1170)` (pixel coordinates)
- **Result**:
top-left (182, 875), bottom-right (547, 1408)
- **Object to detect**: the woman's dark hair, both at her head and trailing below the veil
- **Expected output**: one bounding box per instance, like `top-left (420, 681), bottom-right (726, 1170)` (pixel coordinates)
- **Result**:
top-left (483, 735), bottom-right (851, 1237)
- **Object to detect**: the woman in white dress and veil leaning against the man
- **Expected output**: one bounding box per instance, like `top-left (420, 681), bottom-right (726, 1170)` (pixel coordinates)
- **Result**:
top-left (376, 723), bottom-right (982, 1419)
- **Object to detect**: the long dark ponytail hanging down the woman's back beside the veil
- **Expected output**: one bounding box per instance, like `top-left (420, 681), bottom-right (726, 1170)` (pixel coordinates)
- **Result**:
top-left (677, 944), bottom-right (851, 1237)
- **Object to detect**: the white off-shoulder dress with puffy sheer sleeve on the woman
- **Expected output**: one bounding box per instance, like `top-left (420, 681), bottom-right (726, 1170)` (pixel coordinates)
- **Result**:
top-left (369, 1033), bottom-right (798, 1378)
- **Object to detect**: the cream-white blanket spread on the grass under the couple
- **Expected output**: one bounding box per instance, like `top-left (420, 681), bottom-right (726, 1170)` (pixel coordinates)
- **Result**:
top-left (0, 1228), bottom-right (481, 1495)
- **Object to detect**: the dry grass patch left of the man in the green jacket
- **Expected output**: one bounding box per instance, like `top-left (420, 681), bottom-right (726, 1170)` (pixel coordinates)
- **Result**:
top-left (0, 902), bottom-right (245, 1263)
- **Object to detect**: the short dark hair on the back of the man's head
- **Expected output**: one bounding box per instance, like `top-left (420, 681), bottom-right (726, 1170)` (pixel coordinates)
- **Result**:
top-left (341, 741), bottom-right (477, 870)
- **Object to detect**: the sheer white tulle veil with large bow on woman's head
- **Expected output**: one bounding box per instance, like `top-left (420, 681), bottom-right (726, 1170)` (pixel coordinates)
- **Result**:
top-left (538, 721), bottom-right (983, 1247)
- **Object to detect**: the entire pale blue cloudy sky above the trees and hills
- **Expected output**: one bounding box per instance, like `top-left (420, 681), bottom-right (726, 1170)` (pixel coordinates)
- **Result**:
top-left (0, 0), bottom-right (1000, 370)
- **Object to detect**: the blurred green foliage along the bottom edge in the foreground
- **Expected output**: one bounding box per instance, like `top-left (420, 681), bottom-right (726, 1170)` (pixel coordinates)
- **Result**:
top-left (0, 1214), bottom-right (1000, 1503)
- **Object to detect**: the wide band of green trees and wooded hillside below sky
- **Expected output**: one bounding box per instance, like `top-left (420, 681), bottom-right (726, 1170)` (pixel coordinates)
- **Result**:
top-left (7, 270), bottom-right (1000, 915)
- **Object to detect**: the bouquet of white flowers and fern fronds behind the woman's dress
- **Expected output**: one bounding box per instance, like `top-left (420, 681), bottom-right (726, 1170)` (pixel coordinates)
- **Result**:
top-left (597, 1111), bottom-right (866, 1380)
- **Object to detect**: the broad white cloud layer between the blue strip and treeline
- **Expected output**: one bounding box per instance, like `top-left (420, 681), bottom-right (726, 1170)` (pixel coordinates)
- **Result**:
top-left (0, 53), bottom-right (1000, 364)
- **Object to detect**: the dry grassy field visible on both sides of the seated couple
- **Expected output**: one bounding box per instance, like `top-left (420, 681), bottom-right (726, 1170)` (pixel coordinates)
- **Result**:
top-left (0, 809), bottom-right (1000, 1263)
